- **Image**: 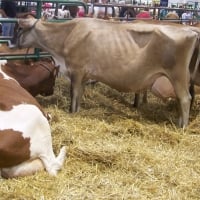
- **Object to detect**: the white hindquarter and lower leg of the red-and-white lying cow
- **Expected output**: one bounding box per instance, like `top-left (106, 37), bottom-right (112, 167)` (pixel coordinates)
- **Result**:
top-left (0, 104), bottom-right (66, 177)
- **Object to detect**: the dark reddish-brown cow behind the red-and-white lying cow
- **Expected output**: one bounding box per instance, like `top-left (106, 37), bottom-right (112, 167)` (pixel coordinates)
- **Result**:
top-left (2, 60), bottom-right (59, 96)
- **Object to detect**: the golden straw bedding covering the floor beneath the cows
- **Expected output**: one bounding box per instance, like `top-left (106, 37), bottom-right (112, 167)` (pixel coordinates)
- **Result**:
top-left (0, 77), bottom-right (200, 200)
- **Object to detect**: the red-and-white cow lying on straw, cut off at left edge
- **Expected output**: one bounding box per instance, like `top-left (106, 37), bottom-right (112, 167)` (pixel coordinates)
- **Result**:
top-left (0, 60), bottom-right (66, 178)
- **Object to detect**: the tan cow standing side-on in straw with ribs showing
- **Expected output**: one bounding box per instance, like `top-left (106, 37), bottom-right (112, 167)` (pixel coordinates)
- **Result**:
top-left (17, 18), bottom-right (199, 127)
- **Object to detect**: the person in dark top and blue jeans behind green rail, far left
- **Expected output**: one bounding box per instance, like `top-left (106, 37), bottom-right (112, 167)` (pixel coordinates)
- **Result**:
top-left (0, 0), bottom-right (17, 36)
